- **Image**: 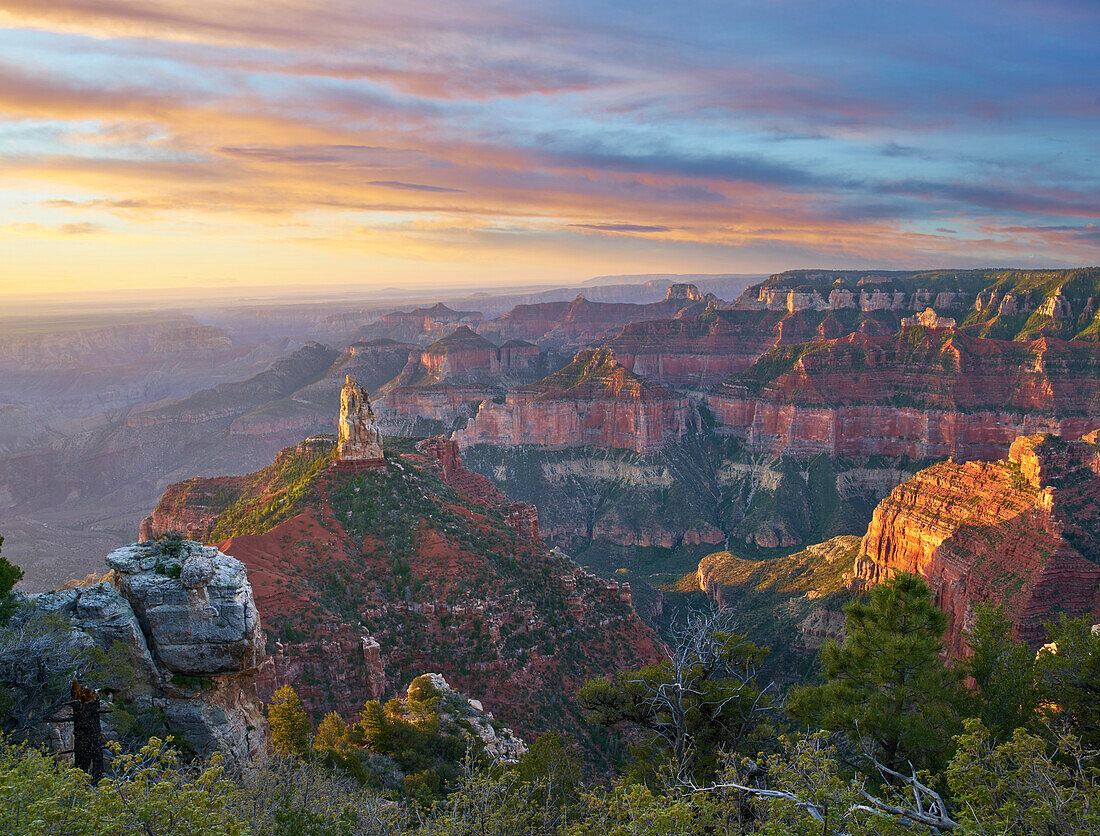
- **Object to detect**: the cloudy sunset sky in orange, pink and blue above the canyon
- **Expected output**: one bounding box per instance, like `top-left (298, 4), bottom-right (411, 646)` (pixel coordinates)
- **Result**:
top-left (0, 0), bottom-right (1100, 294)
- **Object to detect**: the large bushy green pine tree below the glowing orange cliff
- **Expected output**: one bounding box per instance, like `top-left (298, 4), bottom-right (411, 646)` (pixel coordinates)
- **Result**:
top-left (787, 573), bottom-right (960, 770)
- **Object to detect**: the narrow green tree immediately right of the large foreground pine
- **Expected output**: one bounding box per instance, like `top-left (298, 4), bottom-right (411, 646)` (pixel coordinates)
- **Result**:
top-left (960, 603), bottom-right (1038, 740)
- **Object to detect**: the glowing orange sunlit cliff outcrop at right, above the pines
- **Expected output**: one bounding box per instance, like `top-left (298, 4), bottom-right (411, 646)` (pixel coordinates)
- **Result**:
top-left (855, 432), bottom-right (1100, 655)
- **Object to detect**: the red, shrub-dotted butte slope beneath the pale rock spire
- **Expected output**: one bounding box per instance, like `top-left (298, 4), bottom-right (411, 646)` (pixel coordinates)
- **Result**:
top-left (140, 439), bottom-right (656, 752)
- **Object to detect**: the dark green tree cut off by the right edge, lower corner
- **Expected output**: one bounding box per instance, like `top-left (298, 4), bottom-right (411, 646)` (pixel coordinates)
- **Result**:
top-left (1036, 615), bottom-right (1100, 749)
